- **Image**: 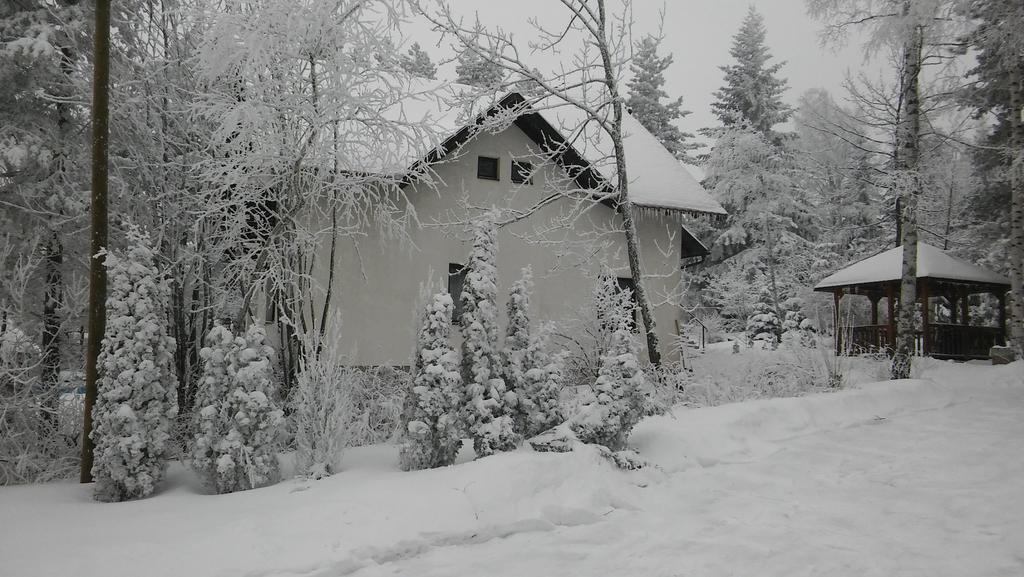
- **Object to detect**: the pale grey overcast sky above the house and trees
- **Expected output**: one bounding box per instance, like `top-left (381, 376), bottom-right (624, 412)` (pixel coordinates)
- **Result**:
top-left (412, 0), bottom-right (879, 145)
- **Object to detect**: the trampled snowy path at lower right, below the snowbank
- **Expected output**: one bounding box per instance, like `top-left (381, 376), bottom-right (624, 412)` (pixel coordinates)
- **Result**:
top-left (337, 368), bottom-right (1024, 577)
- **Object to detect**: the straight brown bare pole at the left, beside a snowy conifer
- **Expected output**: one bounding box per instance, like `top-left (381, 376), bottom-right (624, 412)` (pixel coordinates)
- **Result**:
top-left (79, 0), bottom-right (111, 483)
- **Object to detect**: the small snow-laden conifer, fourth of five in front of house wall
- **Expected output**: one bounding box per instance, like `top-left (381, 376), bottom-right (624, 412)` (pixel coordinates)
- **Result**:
top-left (518, 323), bottom-right (565, 439)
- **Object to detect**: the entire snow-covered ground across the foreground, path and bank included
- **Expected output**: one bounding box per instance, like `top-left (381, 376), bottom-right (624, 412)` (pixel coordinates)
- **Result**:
top-left (0, 362), bottom-right (1024, 577)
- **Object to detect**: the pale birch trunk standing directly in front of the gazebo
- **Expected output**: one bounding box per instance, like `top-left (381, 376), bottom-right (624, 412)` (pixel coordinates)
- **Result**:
top-left (890, 26), bottom-right (923, 379)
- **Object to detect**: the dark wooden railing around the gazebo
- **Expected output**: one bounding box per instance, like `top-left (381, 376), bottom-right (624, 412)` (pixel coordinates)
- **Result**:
top-left (842, 324), bottom-right (1004, 359)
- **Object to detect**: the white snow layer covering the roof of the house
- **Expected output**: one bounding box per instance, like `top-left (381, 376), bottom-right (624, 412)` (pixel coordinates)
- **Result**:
top-left (378, 83), bottom-right (726, 215)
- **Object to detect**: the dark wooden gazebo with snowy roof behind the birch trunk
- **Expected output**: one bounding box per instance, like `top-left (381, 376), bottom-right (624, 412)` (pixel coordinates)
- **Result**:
top-left (814, 243), bottom-right (1010, 359)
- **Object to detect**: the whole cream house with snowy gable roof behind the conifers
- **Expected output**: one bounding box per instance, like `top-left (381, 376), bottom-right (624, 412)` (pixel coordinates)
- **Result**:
top-left (282, 87), bottom-right (725, 365)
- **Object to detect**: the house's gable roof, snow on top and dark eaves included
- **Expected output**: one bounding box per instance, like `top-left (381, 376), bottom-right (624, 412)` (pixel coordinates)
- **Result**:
top-left (385, 84), bottom-right (726, 216)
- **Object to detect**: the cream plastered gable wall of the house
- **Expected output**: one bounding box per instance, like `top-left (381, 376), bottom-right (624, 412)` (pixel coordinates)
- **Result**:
top-left (299, 122), bottom-right (682, 365)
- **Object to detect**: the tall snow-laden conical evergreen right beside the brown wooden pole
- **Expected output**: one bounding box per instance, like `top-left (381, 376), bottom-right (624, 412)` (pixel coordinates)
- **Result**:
top-left (92, 226), bottom-right (178, 501)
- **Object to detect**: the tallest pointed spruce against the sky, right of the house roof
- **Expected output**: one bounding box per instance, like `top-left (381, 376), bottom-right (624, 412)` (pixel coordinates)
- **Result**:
top-left (711, 5), bottom-right (793, 135)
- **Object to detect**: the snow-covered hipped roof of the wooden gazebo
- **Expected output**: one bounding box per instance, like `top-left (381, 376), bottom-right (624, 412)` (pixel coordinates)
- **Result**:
top-left (814, 243), bottom-right (1010, 290)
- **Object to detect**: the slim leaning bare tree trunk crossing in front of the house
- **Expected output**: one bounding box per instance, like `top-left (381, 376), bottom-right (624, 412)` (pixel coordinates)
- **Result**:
top-left (597, 0), bottom-right (662, 367)
